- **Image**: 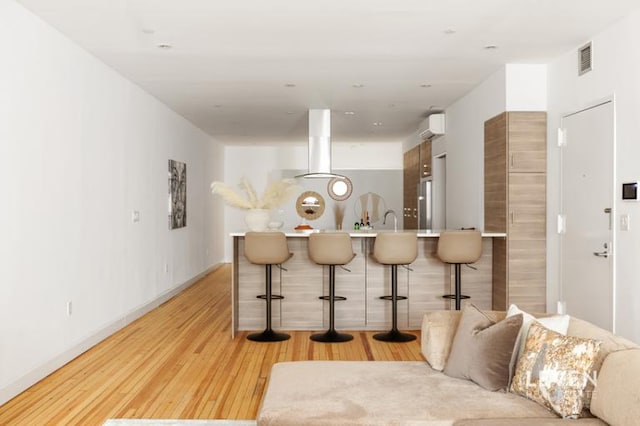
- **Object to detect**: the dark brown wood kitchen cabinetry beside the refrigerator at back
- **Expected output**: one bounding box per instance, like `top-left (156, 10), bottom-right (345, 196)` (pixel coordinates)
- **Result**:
top-left (402, 140), bottom-right (431, 229)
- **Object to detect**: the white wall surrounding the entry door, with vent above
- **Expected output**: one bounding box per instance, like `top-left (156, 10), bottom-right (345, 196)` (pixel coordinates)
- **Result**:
top-left (547, 11), bottom-right (640, 342)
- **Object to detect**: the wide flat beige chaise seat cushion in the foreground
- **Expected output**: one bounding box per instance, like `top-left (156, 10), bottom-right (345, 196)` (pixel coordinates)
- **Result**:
top-left (257, 361), bottom-right (556, 426)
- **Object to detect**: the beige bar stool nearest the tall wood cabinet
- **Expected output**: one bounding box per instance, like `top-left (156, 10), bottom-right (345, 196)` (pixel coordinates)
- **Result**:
top-left (437, 230), bottom-right (482, 311)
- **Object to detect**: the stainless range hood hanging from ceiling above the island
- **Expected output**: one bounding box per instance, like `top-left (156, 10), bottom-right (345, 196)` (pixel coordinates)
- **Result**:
top-left (296, 109), bottom-right (344, 178)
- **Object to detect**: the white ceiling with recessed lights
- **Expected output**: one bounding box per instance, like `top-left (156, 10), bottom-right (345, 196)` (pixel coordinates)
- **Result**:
top-left (18, 0), bottom-right (640, 144)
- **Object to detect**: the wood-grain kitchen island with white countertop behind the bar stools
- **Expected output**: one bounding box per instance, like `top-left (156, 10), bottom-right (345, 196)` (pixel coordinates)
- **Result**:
top-left (231, 231), bottom-right (505, 335)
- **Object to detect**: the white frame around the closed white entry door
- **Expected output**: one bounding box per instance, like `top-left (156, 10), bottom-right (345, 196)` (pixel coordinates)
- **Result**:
top-left (558, 95), bottom-right (618, 333)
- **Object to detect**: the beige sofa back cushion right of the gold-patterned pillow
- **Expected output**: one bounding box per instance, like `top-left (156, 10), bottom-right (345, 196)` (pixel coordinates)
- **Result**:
top-left (591, 349), bottom-right (640, 425)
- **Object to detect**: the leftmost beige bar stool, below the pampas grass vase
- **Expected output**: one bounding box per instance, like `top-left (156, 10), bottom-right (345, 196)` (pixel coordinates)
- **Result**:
top-left (244, 232), bottom-right (293, 342)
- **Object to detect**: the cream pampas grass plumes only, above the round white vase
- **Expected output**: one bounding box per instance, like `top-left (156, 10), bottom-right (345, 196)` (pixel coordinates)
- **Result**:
top-left (211, 178), bottom-right (298, 209)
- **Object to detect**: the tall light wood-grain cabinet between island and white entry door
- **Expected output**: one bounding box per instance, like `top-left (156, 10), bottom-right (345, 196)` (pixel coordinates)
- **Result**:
top-left (484, 112), bottom-right (547, 312)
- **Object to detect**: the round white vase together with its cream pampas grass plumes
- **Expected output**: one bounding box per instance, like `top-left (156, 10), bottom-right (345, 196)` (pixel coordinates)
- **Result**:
top-left (211, 178), bottom-right (298, 232)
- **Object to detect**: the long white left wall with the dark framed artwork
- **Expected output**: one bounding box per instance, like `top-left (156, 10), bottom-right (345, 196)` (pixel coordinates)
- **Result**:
top-left (0, 0), bottom-right (223, 404)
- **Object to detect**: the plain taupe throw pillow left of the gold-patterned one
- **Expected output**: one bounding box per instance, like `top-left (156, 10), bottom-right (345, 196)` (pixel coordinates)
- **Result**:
top-left (444, 304), bottom-right (522, 391)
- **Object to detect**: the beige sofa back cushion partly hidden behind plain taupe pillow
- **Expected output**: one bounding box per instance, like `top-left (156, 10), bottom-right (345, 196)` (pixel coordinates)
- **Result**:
top-left (420, 310), bottom-right (505, 371)
